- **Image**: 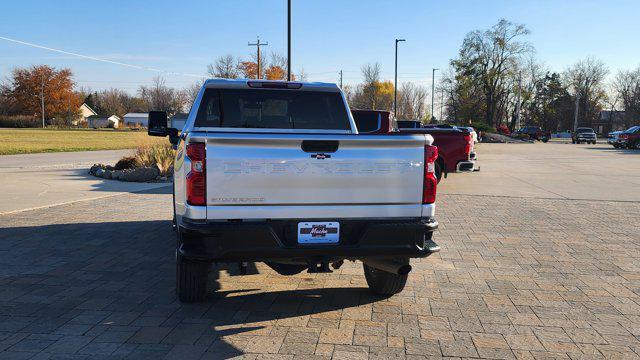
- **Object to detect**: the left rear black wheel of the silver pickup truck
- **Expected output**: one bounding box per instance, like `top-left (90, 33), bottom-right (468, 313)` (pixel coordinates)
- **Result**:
top-left (176, 229), bottom-right (210, 302)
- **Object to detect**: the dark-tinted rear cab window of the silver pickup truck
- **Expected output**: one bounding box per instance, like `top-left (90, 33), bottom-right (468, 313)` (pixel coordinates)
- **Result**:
top-left (195, 88), bottom-right (351, 131)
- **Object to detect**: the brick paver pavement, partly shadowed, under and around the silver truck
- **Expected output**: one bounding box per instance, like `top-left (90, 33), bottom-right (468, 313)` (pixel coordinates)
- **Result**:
top-left (0, 187), bottom-right (640, 359)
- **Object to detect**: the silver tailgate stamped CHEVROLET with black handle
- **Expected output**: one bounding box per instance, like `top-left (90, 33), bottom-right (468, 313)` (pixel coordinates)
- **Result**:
top-left (203, 133), bottom-right (430, 219)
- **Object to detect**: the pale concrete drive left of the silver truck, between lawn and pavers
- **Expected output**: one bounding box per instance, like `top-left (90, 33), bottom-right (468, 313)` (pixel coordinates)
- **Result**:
top-left (0, 150), bottom-right (166, 214)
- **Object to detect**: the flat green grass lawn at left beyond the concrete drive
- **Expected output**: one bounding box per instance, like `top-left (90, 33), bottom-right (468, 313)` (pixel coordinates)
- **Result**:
top-left (0, 128), bottom-right (167, 155)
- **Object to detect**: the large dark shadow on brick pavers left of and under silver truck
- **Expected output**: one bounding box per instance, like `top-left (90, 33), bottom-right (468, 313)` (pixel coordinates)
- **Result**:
top-left (0, 220), bottom-right (381, 358)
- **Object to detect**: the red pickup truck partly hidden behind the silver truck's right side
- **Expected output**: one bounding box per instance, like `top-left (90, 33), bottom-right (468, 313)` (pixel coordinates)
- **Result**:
top-left (351, 109), bottom-right (476, 182)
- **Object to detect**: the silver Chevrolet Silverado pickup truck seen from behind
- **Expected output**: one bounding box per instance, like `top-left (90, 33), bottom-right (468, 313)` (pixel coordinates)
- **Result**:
top-left (149, 80), bottom-right (439, 302)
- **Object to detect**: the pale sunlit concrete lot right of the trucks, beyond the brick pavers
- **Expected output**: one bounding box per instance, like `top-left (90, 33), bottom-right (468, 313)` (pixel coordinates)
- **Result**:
top-left (440, 142), bottom-right (640, 201)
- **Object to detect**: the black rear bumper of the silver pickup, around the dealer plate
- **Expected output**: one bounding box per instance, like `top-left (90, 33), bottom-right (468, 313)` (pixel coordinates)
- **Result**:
top-left (178, 218), bottom-right (438, 262)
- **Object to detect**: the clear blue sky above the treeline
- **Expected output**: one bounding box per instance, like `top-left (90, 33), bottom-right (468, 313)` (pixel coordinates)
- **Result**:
top-left (0, 0), bottom-right (640, 92)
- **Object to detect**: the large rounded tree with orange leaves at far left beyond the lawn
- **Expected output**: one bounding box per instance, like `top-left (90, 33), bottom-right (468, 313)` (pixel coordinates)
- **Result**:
top-left (2, 65), bottom-right (83, 125)
